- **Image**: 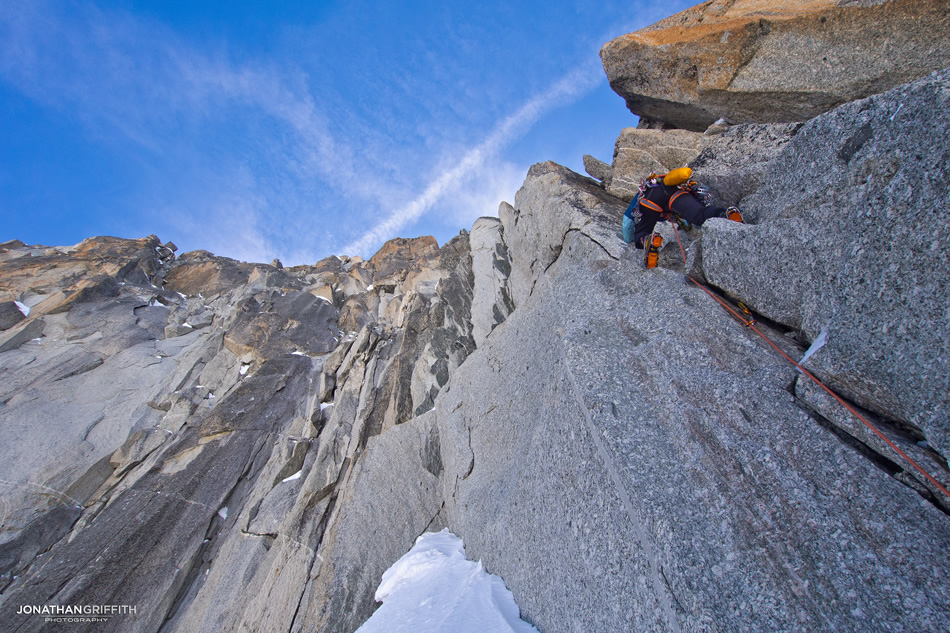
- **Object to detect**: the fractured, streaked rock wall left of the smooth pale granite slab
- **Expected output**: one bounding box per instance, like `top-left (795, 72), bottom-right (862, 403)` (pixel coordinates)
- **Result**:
top-left (0, 226), bottom-right (490, 631)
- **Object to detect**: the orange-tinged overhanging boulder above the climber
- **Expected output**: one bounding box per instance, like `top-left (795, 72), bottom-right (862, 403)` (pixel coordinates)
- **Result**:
top-left (600, 0), bottom-right (950, 132)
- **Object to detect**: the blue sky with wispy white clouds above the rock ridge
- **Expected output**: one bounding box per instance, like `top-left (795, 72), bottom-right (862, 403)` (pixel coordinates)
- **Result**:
top-left (0, 0), bottom-right (692, 265)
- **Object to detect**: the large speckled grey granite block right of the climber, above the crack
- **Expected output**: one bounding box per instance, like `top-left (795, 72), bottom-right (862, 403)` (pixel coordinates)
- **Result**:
top-left (703, 65), bottom-right (950, 452)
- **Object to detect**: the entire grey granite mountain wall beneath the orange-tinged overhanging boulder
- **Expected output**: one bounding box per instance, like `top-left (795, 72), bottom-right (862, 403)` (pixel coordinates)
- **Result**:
top-left (0, 25), bottom-right (950, 633)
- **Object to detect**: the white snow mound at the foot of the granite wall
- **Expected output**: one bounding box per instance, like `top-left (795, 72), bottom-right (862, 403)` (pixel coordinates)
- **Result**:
top-left (357, 530), bottom-right (538, 633)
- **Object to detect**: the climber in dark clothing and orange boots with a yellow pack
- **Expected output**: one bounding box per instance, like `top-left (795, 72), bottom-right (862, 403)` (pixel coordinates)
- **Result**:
top-left (623, 167), bottom-right (742, 268)
